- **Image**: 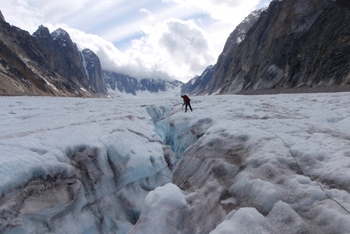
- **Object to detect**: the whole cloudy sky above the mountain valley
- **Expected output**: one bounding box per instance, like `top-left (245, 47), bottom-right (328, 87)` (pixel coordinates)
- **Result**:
top-left (0, 0), bottom-right (271, 82)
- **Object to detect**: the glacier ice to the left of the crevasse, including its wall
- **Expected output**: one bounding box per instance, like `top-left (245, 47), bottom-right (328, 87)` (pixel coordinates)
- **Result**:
top-left (0, 97), bottom-right (175, 233)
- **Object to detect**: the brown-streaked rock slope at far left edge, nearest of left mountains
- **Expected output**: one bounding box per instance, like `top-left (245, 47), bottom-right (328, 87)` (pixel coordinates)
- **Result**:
top-left (0, 21), bottom-right (50, 95)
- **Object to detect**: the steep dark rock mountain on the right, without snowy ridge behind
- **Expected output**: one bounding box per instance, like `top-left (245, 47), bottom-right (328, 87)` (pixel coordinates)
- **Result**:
top-left (208, 0), bottom-right (350, 94)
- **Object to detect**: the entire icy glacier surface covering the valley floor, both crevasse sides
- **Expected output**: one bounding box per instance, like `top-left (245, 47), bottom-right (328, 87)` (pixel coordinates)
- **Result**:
top-left (0, 93), bottom-right (350, 234)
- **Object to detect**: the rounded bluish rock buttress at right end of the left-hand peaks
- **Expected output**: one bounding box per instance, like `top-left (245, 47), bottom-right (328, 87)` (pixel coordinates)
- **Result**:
top-left (82, 49), bottom-right (108, 95)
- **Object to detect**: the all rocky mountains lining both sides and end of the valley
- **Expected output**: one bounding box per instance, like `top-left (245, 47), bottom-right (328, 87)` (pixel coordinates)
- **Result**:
top-left (0, 0), bottom-right (350, 97)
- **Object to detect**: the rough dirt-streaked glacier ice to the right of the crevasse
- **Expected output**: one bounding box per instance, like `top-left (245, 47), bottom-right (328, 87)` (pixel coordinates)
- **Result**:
top-left (132, 93), bottom-right (350, 233)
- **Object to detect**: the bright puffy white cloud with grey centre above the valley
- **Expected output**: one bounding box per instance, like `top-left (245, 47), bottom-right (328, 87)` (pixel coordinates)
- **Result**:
top-left (121, 19), bottom-right (215, 81)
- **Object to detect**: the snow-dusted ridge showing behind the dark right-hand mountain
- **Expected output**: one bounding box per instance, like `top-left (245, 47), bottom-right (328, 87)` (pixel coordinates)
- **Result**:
top-left (181, 8), bottom-right (266, 95)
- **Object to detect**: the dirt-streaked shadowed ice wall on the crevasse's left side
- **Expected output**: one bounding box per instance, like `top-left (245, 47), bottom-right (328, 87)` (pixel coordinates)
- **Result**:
top-left (1, 142), bottom-right (173, 233)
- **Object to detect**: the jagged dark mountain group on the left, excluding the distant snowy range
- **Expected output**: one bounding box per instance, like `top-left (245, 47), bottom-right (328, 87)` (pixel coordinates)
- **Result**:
top-left (0, 13), bottom-right (107, 97)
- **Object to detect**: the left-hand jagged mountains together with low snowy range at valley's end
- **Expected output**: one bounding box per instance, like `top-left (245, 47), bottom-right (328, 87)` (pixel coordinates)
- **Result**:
top-left (0, 11), bottom-right (182, 97)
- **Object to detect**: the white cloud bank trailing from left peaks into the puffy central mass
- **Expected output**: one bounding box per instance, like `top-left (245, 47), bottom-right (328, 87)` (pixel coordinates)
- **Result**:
top-left (45, 19), bottom-right (216, 82)
